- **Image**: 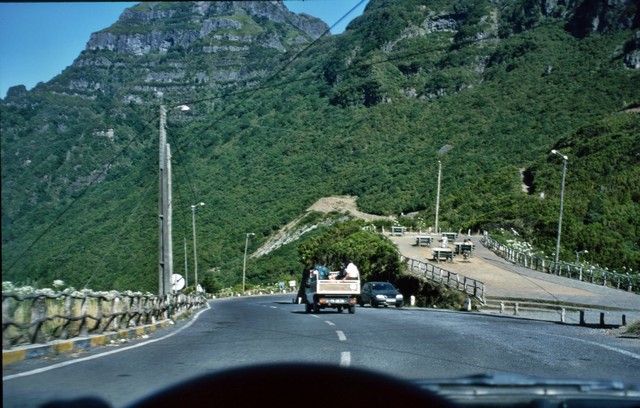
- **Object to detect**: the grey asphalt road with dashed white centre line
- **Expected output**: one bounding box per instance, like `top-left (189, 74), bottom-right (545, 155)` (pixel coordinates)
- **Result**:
top-left (3, 294), bottom-right (640, 407)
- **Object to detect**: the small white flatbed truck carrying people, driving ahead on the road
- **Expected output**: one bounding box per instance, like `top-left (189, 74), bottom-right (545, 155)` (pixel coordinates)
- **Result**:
top-left (305, 272), bottom-right (360, 314)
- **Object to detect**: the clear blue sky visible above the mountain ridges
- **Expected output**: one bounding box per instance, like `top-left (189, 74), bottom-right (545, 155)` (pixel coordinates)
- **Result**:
top-left (0, 0), bottom-right (368, 98)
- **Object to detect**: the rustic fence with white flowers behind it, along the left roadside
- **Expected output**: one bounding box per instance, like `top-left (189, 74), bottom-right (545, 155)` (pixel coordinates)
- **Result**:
top-left (2, 292), bottom-right (206, 349)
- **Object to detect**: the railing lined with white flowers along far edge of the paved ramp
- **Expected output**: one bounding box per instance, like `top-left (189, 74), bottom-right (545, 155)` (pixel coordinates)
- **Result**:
top-left (481, 235), bottom-right (640, 293)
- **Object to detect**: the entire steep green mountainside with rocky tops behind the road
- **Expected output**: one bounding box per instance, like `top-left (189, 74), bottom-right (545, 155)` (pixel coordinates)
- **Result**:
top-left (0, 0), bottom-right (640, 291)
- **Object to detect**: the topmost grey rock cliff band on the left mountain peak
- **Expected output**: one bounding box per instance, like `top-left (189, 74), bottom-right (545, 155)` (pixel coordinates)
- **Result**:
top-left (87, 1), bottom-right (328, 54)
